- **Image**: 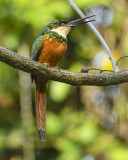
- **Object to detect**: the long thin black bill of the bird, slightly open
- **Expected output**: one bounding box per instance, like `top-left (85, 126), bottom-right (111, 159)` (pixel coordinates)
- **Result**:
top-left (66, 15), bottom-right (95, 27)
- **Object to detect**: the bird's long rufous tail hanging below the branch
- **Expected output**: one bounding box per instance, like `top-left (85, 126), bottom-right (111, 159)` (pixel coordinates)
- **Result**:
top-left (36, 76), bottom-right (46, 141)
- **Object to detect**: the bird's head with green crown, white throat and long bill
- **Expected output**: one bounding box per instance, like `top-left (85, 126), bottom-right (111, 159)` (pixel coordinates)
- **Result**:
top-left (43, 15), bottom-right (94, 38)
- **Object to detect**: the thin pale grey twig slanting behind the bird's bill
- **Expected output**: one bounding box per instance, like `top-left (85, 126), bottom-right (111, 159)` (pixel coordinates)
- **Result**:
top-left (69, 0), bottom-right (119, 72)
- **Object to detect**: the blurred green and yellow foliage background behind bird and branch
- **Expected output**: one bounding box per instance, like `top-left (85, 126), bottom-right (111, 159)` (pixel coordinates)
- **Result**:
top-left (0, 0), bottom-right (128, 160)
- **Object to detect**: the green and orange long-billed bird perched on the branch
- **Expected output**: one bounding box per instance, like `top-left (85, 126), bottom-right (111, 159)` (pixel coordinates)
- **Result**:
top-left (31, 15), bottom-right (94, 141)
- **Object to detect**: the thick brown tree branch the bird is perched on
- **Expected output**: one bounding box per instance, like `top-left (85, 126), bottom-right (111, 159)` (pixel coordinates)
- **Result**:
top-left (0, 47), bottom-right (128, 86)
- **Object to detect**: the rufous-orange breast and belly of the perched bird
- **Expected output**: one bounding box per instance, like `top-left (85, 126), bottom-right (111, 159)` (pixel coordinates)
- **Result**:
top-left (38, 39), bottom-right (67, 67)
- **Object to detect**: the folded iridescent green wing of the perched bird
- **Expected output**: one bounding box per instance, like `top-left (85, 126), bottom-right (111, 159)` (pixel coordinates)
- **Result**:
top-left (31, 35), bottom-right (44, 61)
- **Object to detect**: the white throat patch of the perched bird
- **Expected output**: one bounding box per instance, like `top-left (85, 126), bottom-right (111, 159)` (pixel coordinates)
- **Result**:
top-left (51, 27), bottom-right (71, 38)
